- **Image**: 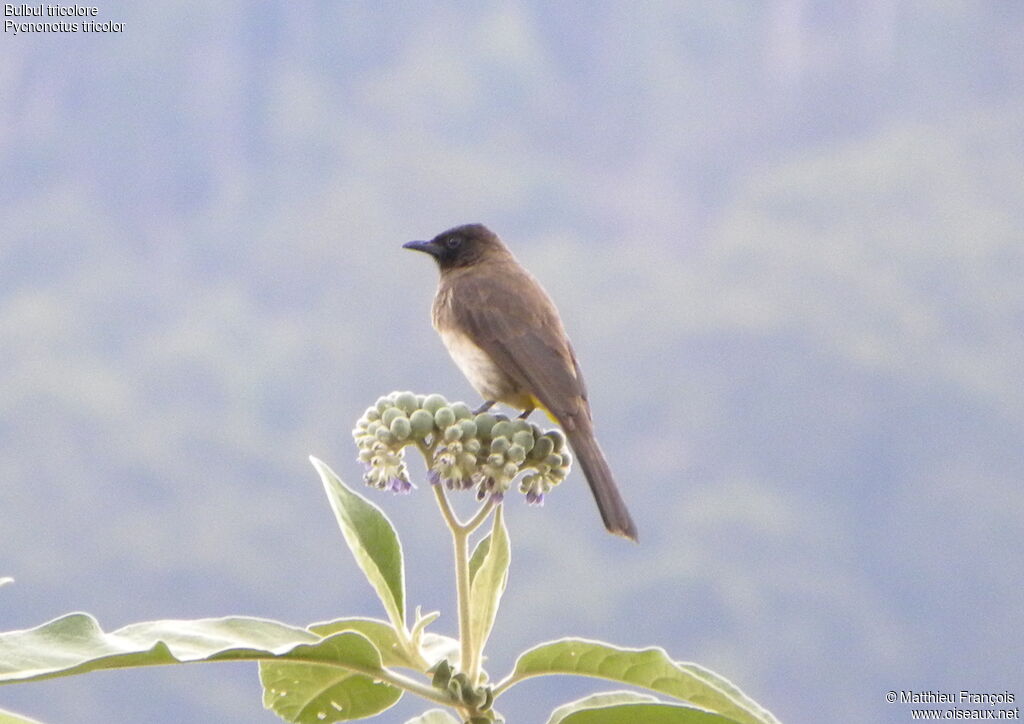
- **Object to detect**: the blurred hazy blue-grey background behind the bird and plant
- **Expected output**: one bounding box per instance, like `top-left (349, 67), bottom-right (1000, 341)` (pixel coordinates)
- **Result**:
top-left (0, 0), bottom-right (1024, 724)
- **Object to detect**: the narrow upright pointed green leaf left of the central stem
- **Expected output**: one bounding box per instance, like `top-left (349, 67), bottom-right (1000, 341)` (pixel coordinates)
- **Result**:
top-left (309, 457), bottom-right (406, 628)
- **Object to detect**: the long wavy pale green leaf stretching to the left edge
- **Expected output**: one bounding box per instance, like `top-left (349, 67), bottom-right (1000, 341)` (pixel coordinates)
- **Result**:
top-left (0, 613), bottom-right (380, 683)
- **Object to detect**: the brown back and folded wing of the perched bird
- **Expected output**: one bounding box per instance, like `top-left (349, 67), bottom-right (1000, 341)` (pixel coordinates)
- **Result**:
top-left (453, 269), bottom-right (590, 429)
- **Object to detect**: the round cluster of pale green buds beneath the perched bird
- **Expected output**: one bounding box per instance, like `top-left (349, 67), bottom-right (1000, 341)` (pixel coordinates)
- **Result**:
top-left (352, 392), bottom-right (572, 504)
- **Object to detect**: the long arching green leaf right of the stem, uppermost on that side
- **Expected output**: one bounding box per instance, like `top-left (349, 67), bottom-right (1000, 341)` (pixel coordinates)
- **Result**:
top-left (511, 639), bottom-right (778, 724)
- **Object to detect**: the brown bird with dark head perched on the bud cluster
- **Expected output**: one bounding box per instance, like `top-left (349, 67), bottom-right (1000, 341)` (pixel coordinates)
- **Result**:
top-left (402, 223), bottom-right (638, 541)
